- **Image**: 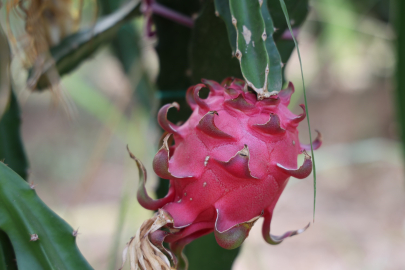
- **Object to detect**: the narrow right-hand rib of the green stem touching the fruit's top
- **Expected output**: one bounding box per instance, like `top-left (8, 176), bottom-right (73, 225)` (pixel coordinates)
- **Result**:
top-left (261, 1), bottom-right (283, 92)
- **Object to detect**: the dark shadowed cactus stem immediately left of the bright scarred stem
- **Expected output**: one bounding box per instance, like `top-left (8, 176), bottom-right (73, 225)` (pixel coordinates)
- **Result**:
top-left (190, 1), bottom-right (242, 84)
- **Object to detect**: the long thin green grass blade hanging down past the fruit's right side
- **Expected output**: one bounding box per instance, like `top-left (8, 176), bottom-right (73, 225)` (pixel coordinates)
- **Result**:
top-left (279, 0), bottom-right (316, 221)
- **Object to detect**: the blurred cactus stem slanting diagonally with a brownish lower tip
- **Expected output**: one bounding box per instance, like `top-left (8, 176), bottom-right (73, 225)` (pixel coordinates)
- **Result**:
top-left (27, 0), bottom-right (142, 90)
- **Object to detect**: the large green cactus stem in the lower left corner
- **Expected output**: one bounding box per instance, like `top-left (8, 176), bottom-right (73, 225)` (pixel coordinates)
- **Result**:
top-left (0, 163), bottom-right (92, 270)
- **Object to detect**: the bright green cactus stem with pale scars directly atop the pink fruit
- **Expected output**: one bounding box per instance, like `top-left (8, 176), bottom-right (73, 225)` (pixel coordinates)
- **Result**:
top-left (230, 0), bottom-right (282, 99)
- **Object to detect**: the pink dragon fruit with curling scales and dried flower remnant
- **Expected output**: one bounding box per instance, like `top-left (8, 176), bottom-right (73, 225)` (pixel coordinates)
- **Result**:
top-left (124, 78), bottom-right (322, 269)
